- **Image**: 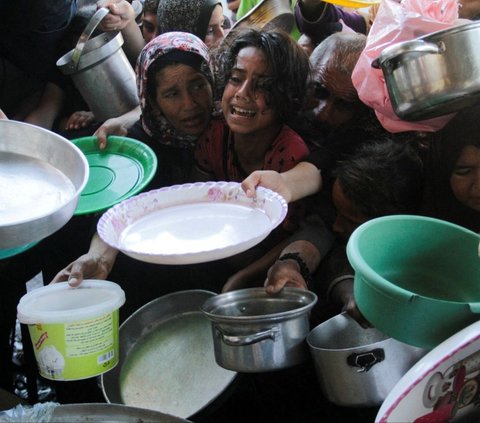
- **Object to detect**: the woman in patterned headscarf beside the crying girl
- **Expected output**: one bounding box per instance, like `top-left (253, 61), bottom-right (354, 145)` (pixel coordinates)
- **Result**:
top-left (127, 32), bottom-right (213, 187)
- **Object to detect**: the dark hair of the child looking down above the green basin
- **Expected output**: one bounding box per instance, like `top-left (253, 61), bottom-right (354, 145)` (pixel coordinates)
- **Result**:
top-left (335, 138), bottom-right (423, 218)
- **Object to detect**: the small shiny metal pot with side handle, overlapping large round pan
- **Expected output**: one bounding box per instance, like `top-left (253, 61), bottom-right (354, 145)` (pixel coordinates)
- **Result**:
top-left (200, 288), bottom-right (317, 372)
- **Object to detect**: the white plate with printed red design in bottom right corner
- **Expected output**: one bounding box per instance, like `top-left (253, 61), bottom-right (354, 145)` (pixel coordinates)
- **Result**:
top-left (375, 321), bottom-right (480, 423)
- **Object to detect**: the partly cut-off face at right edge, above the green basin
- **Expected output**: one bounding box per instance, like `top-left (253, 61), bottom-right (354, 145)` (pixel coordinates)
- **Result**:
top-left (450, 145), bottom-right (480, 212)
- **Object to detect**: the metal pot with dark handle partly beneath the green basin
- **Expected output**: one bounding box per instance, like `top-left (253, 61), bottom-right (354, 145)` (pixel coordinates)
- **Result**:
top-left (307, 313), bottom-right (428, 407)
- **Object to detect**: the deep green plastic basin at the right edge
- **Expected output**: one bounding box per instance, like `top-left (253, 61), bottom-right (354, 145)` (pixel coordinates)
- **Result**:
top-left (347, 215), bottom-right (480, 349)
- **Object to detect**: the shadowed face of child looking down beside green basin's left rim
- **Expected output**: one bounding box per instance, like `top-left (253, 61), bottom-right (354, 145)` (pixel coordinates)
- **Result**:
top-left (332, 179), bottom-right (369, 240)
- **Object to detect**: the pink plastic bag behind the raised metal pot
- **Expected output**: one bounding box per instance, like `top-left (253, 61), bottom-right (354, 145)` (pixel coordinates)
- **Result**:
top-left (352, 0), bottom-right (464, 133)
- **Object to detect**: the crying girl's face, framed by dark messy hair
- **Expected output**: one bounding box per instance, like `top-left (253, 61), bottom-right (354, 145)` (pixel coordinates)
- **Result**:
top-left (222, 47), bottom-right (277, 134)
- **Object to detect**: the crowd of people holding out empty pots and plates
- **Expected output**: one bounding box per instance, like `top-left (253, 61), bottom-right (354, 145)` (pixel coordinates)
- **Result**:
top-left (0, 0), bottom-right (480, 421)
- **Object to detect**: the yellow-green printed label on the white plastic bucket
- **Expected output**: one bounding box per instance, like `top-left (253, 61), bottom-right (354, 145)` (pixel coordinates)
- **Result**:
top-left (29, 310), bottom-right (118, 380)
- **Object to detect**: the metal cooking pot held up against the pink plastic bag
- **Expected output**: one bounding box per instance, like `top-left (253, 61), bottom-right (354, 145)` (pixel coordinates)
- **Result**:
top-left (372, 22), bottom-right (480, 121)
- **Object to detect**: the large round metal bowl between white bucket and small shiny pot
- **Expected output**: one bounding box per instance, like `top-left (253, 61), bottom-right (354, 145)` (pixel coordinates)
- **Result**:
top-left (101, 289), bottom-right (237, 419)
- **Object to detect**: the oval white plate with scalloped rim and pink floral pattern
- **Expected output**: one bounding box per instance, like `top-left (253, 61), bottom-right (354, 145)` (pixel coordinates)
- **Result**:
top-left (97, 182), bottom-right (288, 264)
